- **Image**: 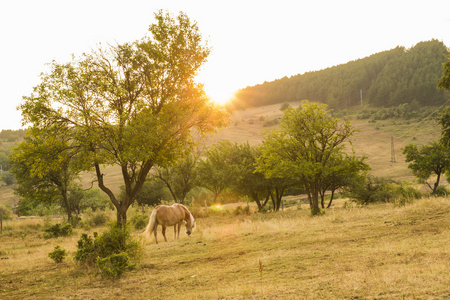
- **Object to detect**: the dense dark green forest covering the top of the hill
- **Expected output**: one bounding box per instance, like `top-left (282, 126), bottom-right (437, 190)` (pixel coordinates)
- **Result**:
top-left (228, 40), bottom-right (450, 110)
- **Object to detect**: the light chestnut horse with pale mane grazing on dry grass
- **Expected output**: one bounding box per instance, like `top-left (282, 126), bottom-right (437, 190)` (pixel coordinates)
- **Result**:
top-left (144, 203), bottom-right (195, 244)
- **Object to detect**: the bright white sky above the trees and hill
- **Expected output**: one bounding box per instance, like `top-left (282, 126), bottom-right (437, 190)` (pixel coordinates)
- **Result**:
top-left (0, 0), bottom-right (450, 129)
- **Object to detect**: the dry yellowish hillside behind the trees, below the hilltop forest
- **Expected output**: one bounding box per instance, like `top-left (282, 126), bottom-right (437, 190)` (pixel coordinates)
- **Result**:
top-left (0, 102), bottom-right (445, 209)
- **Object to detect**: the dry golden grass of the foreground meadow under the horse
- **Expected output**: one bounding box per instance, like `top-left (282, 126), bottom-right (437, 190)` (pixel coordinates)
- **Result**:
top-left (0, 198), bottom-right (450, 299)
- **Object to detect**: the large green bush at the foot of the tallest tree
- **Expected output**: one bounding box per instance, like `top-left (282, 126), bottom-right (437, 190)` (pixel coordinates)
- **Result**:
top-left (74, 223), bottom-right (141, 279)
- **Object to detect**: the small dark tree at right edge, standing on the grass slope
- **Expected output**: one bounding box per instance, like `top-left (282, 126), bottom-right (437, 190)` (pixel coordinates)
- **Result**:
top-left (403, 142), bottom-right (450, 195)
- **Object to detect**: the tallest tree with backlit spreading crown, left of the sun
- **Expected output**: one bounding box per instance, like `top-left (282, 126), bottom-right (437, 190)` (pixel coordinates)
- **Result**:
top-left (20, 11), bottom-right (226, 225)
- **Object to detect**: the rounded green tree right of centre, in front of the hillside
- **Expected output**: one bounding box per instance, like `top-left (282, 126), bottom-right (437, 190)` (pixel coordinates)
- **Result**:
top-left (257, 101), bottom-right (354, 215)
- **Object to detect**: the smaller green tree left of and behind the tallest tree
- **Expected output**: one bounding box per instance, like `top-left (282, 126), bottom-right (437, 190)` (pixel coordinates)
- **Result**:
top-left (10, 127), bottom-right (85, 220)
